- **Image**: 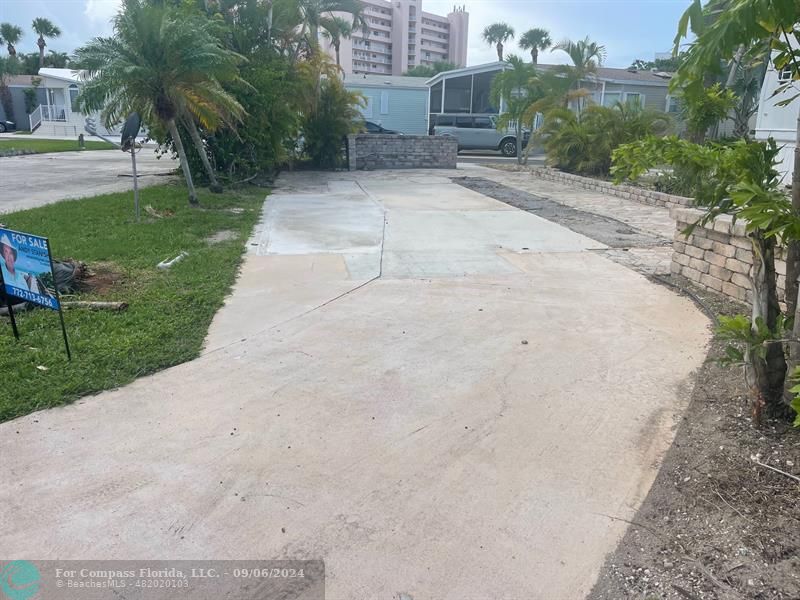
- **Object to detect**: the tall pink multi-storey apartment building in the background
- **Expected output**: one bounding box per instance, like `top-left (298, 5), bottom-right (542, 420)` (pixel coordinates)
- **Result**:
top-left (321, 0), bottom-right (469, 75)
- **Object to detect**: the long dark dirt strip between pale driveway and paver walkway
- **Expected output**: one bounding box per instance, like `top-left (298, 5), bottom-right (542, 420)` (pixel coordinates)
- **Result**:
top-left (452, 177), bottom-right (672, 248)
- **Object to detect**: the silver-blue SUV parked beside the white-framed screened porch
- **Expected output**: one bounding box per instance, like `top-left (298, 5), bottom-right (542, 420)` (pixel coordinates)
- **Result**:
top-left (431, 115), bottom-right (531, 156)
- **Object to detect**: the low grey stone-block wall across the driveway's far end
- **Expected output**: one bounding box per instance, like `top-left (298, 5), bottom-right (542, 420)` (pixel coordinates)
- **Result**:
top-left (347, 133), bottom-right (458, 171)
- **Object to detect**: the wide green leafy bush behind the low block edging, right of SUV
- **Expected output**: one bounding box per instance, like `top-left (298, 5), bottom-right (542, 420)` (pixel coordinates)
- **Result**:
top-left (537, 103), bottom-right (670, 176)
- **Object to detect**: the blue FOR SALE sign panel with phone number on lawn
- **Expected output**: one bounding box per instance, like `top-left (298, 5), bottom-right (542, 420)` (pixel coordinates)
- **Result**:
top-left (0, 228), bottom-right (59, 310)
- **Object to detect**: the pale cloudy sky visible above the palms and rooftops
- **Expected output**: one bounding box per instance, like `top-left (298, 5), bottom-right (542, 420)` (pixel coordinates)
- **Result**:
top-left (0, 0), bottom-right (690, 67)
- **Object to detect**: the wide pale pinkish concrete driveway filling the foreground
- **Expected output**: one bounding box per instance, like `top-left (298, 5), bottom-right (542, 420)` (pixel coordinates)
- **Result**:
top-left (0, 167), bottom-right (709, 600)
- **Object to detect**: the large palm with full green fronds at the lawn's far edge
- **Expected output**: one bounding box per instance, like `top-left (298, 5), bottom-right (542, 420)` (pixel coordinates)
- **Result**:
top-left (74, 0), bottom-right (244, 206)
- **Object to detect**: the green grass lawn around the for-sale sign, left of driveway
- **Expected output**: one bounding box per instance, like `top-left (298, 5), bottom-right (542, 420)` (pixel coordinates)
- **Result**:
top-left (0, 185), bottom-right (265, 421)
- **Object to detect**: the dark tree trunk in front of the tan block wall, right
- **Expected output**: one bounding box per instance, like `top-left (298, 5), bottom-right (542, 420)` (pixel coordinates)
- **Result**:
top-left (747, 231), bottom-right (786, 424)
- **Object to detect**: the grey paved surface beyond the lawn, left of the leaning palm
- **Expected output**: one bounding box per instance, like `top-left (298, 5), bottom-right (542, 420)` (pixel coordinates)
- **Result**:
top-left (0, 148), bottom-right (177, 213)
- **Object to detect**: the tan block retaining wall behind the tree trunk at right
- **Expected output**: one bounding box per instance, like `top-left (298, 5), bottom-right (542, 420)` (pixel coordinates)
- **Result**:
top-left (670, 208), bottom-right (786, 310)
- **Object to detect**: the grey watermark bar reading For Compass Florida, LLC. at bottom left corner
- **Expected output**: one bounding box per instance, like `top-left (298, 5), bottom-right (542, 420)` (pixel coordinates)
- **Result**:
top-left (0, 560), bottom-right (325, 600)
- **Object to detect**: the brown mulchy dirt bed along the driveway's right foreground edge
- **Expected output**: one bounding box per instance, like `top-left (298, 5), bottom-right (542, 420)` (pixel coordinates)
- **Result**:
top-left (589, 277), bottom-right (800, 600)
